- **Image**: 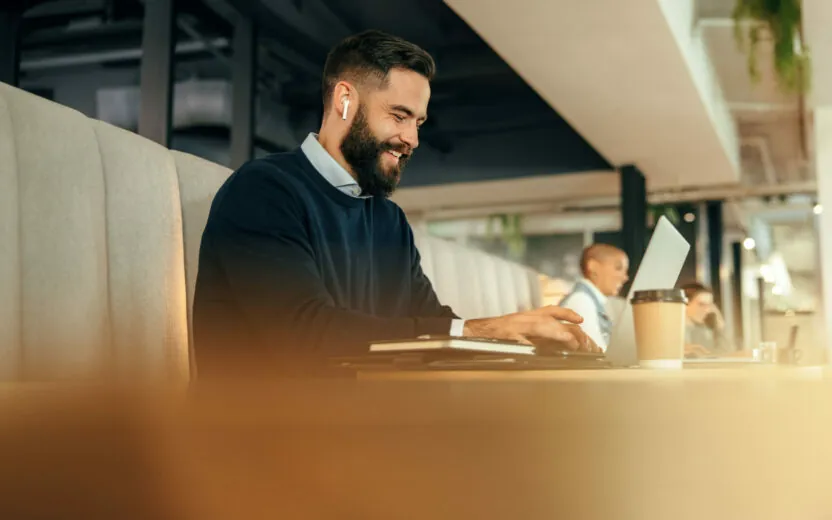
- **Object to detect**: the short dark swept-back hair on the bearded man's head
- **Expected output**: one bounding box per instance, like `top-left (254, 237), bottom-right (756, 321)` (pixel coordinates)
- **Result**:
top-left (323, 30), bottom-right (436, 110)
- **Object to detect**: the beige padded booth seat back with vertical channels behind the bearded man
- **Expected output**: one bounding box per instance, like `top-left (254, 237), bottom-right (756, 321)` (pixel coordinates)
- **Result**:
top-left (0, 84), bottom-right (539, 381)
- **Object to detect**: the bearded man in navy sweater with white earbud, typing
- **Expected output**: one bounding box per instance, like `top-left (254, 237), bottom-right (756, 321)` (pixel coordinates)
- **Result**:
top-left (194, 31), bottom-right (594, 373)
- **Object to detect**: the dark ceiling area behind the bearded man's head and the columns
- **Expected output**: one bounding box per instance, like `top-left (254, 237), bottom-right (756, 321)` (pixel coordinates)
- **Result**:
top-left (21, 0), bottom-right (611, 186)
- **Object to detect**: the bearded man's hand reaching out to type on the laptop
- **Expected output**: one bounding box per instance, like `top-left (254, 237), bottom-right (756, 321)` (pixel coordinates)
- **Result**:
top-left (463, 305), bottom-right (601, 352)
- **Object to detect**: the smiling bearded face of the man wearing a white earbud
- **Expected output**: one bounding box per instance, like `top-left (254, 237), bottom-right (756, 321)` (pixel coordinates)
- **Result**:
top-left (341, 69), bottom-right (430, 197)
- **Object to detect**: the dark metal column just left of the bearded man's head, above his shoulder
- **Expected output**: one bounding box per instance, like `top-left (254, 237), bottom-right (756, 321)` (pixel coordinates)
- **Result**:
top-left (231, 14), bottom-right (257, 169)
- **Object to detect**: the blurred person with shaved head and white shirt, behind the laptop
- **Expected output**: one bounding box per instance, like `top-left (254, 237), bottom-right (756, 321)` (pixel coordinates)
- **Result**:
top-left (560, 244), bottom-right (630, 351)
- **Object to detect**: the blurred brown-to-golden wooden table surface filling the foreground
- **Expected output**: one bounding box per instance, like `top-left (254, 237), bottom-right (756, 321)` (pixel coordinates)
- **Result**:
top-left (0, 367), bottom-right (832, 520)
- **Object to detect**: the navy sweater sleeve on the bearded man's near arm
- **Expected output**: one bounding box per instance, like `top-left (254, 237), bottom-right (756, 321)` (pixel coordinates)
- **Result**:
top-left (209, 163), bottom-right (451, 355)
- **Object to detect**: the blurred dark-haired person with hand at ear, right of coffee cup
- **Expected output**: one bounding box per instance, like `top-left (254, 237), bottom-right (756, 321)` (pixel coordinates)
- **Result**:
top-left (682, 282), bottom-right (733, 357)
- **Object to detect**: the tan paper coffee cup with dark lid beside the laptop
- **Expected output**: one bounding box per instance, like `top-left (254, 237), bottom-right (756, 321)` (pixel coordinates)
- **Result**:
top-left (631, 289), bottom-right (687, 368)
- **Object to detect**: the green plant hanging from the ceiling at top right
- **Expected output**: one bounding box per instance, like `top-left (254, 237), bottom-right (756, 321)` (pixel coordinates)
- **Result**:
top-left (732, 0), bottom-right (811, 93)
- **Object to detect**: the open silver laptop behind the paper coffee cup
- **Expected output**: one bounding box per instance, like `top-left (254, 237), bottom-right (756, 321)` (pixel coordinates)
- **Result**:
top-left (606, 217), bottom-right (690, 367)
